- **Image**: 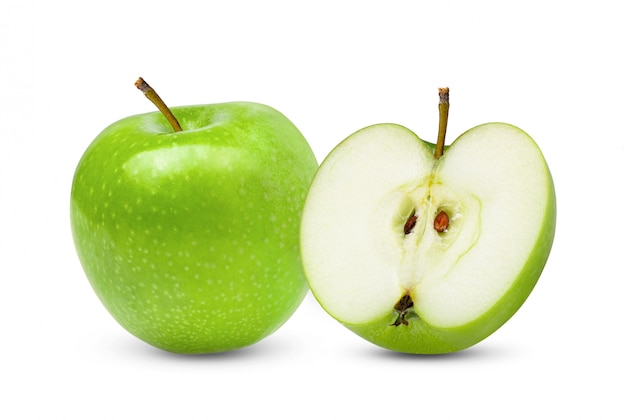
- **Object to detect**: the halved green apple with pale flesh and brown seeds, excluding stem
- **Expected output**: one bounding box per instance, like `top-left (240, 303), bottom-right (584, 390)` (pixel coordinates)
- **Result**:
top-left (301, 123), bottom-right (556, 354)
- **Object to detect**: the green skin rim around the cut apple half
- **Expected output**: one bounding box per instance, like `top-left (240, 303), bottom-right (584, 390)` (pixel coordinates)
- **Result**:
top-left (305, 123), bottom-right (556, 354)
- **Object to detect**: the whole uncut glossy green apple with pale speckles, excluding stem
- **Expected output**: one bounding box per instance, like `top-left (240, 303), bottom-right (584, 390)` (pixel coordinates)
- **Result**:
top-left (70, 102), bottom-right (318, 353)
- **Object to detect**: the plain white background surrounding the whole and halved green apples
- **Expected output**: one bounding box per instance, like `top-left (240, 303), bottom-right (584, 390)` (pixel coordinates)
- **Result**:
top-left (0, 0), bottom-right (626, 419)
